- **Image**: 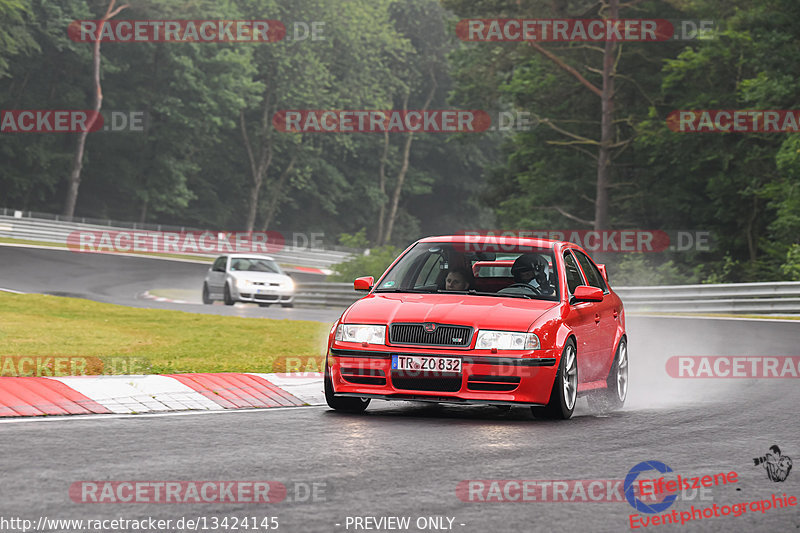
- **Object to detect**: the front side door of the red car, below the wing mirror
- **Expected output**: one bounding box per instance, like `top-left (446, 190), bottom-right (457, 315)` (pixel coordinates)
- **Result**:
top-left (563, 250), bottom-right (598, 383)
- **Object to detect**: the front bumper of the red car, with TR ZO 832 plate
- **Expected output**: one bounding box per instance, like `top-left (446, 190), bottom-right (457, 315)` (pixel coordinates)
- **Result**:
top-left (328, 346), bottom-right (560, 405)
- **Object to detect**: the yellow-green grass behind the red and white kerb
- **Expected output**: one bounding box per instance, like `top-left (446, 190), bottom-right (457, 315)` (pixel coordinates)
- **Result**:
top-left (0, 292), bottom-right (330, 375)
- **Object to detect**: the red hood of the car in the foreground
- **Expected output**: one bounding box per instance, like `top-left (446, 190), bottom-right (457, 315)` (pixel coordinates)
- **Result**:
top-left (343, 293), bottom-right (558, 331)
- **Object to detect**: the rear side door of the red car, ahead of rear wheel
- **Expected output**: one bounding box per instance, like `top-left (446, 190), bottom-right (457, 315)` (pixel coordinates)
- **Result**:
top-left (573, 250), bottom-right (619, 381)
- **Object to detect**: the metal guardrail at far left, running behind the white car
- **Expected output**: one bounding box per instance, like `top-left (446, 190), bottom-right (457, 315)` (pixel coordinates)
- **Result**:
top-left (0, 209), bottom-right (353, 269)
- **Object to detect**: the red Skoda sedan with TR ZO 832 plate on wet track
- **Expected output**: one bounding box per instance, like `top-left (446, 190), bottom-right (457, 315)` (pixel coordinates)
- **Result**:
top-left (325, 235), bottom-right (628, 419)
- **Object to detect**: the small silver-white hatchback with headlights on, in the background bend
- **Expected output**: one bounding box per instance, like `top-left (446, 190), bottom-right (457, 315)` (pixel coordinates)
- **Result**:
top-left (203, 254), bottom-right (294, 307)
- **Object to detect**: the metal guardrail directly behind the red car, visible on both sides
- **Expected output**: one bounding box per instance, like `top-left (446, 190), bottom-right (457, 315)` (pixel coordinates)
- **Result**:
top-left (295, 281), bottom-right (800, 315)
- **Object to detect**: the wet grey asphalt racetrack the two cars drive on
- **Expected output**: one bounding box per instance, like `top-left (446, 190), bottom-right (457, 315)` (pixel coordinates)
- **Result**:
top-left (0, 243), bottom-right (800, 533)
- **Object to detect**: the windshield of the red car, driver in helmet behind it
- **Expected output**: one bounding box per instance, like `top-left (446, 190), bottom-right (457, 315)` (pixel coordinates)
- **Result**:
top-left (375, 242), bottom-right (559, 300)
